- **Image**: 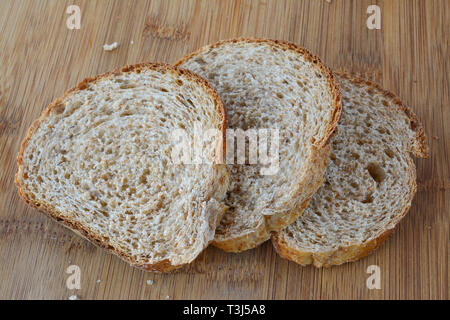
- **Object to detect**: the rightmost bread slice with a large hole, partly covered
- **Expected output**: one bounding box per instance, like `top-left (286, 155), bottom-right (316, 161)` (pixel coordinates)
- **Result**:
top-left (272, 74), bottom-right (428, 267)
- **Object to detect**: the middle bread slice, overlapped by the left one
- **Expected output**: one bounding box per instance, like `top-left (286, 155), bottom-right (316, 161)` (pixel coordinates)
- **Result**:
top-left (175, 39), bottom-right (341, 252)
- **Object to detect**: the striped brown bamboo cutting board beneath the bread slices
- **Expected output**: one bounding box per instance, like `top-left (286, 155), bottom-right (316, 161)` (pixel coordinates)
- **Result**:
top-left (0, 0), bottom-right (450, 299)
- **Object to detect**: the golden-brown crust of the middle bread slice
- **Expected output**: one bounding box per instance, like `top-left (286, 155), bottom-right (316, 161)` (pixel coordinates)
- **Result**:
top-left (174, 38), bottom-right (342, 252)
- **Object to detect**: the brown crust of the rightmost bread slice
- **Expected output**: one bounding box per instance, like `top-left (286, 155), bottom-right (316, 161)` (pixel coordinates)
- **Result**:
top-left (271, 73), bottom-right (428, 268)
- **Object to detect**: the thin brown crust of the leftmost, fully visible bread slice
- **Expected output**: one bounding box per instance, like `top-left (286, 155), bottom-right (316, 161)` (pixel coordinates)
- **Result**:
top-left (14, 63), bottom-right (226, 272)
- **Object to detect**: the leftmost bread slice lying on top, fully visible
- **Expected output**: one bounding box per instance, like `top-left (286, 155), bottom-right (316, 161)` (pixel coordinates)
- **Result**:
top-left (16, 63), bottom-right (229, 272)
